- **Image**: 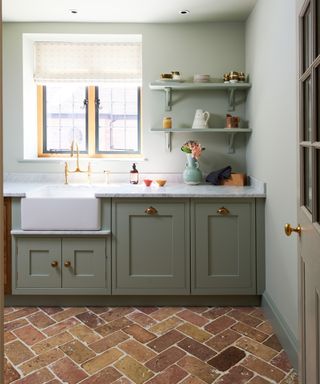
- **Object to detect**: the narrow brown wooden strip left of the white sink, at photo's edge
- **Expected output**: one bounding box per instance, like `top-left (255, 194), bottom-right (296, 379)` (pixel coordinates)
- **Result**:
top-left (3, 197), bottom-right (12, 294)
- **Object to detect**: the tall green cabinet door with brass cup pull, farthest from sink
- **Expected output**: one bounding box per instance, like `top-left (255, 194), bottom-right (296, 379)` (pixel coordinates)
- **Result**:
top-left (192, 201), bottom-right (256, 294)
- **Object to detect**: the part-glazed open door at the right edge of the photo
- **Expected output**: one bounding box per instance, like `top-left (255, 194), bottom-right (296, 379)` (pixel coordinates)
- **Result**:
top-left (293, 0), bottom-right (320, 384)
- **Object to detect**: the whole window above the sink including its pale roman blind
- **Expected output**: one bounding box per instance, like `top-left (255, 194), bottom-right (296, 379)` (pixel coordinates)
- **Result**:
top-left (34, 35), bottom-right (142, 157)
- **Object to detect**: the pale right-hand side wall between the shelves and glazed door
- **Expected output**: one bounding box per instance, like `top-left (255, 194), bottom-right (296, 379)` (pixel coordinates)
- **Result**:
top-left (246, 0), bottom-right (298, 337)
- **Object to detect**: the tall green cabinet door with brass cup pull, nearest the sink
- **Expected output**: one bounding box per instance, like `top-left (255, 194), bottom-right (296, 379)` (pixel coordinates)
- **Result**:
top-left (112, 200), bottom-right (190, 295)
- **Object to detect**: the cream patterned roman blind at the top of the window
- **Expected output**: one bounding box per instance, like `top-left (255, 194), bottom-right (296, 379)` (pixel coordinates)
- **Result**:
top-left (34, 41), bottom-right (142, 83)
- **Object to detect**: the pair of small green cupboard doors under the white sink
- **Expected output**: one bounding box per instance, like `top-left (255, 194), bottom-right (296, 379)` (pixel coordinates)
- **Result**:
top-left (15, 237), bottom-right (108, 294)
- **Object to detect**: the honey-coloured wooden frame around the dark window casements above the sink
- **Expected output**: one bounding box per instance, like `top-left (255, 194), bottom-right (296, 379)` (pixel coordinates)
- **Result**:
top-left (37, 85), bottom-right (143, 159)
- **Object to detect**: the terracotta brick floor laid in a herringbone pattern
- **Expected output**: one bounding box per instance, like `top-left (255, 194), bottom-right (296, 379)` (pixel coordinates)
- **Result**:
top-left (4, 307), bottom-right (298, 384)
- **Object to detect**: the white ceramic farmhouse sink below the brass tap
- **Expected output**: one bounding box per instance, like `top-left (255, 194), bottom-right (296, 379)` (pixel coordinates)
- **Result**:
top-left (21, 185), bottom-right (101, 231)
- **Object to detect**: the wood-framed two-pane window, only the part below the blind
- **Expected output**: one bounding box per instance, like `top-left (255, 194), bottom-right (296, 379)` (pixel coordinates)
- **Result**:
top-left (38, 84), bottom-right (141, 157)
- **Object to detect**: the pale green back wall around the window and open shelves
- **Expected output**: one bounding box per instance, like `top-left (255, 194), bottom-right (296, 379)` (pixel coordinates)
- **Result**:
top-left (3, 23), bottom-right (246, 172)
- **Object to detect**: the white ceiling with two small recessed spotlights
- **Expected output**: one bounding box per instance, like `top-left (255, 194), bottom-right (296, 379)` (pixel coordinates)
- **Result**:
top-left (2, 0), bottom-right (257, 23)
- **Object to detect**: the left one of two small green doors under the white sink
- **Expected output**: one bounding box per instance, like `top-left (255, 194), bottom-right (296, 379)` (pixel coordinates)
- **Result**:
top-left (16, 238), bottom-right (61, 288)
